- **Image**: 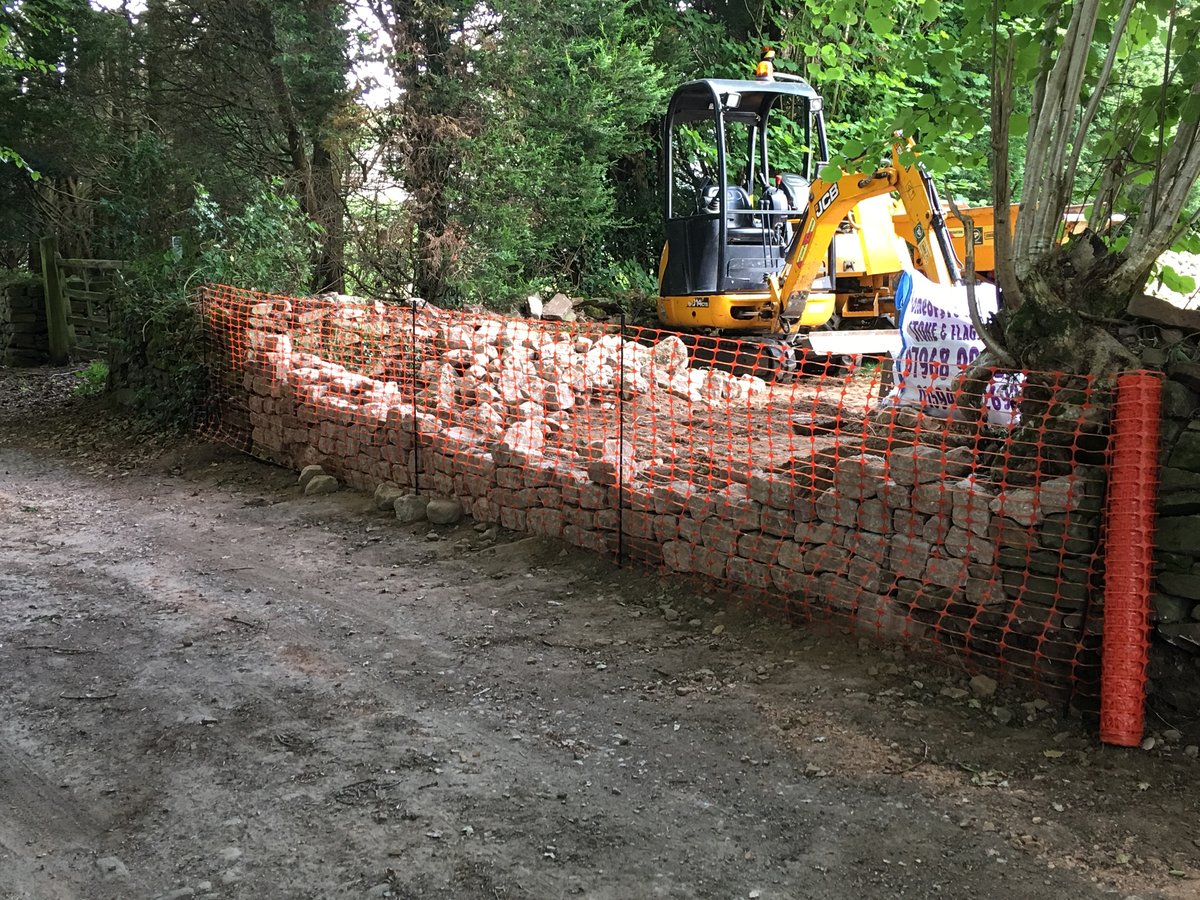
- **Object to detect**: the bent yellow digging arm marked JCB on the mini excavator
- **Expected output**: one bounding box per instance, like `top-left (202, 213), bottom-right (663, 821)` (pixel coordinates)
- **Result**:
top-left (767, 142), bottom-right (961, 320)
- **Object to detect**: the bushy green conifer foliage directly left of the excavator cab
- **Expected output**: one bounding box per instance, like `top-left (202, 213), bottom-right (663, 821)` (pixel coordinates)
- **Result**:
top-left (451, 0), bottom-right (666, 306)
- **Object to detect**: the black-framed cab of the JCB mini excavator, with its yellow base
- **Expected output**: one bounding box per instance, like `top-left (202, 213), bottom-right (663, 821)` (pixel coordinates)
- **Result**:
top-left (659, 66), bottom-right (828, 331)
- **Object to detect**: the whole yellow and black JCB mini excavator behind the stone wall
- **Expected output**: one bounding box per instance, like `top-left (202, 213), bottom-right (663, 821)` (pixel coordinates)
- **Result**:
top-left (658, 50), bottom-right (960, 370)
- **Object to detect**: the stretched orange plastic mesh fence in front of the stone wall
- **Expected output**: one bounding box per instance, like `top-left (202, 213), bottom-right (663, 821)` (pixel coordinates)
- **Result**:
top-left (203, 287), bottom-right (1161, 698)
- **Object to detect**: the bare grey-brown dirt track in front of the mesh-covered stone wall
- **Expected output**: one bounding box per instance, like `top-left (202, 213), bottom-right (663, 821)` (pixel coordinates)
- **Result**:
top-left (0, 370), bottom-right (1200, 900)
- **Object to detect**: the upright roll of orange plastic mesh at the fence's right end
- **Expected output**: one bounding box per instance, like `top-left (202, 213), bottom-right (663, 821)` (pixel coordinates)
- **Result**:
top-left (1100, 372), bottom-right (1162, 746)
